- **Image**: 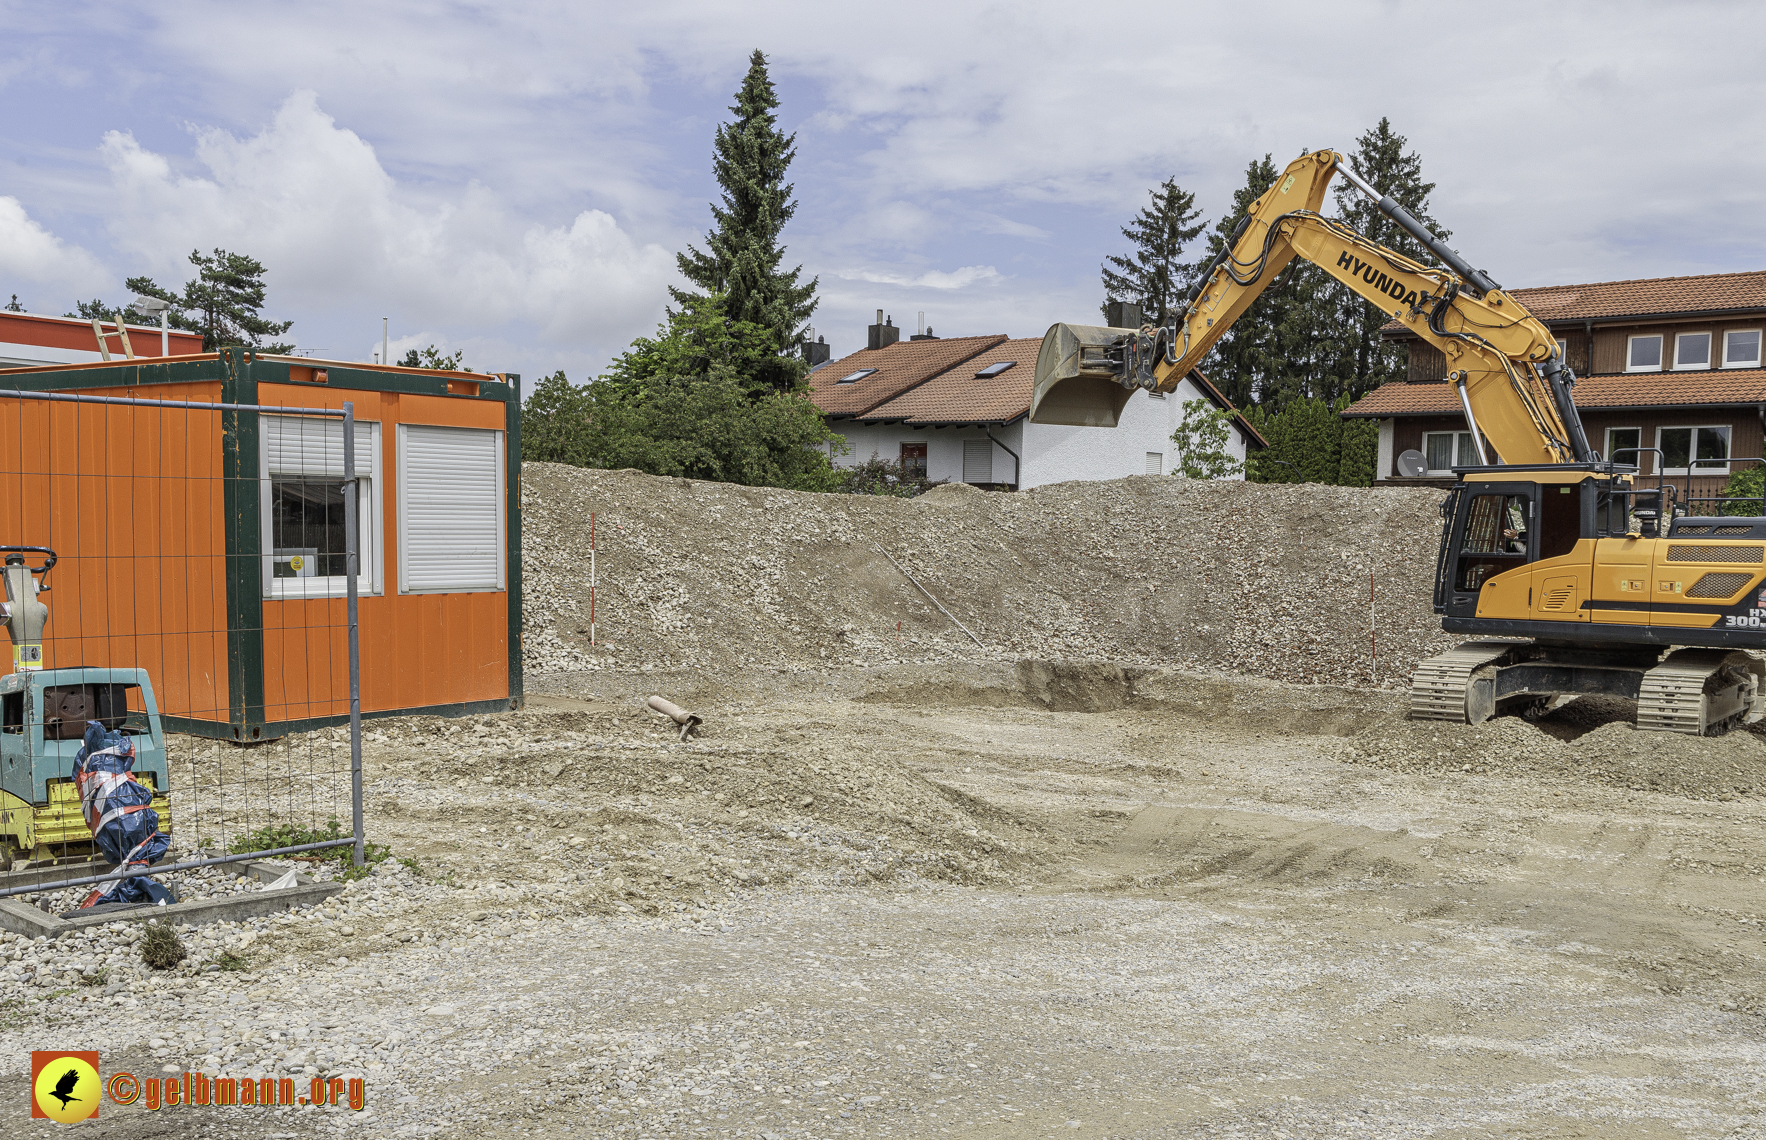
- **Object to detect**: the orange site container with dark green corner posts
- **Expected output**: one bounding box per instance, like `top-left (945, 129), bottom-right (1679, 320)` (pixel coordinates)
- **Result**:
top-left (0, 348), bottom-right (521, 741)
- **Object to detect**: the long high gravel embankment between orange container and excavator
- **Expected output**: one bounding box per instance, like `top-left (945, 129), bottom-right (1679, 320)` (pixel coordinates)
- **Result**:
top-left (523, 464), bottom-right (1452, 688)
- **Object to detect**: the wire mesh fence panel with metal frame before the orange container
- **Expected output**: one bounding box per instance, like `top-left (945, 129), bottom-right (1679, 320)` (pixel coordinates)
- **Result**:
top-left (0, 388), bottom-right (362, 916)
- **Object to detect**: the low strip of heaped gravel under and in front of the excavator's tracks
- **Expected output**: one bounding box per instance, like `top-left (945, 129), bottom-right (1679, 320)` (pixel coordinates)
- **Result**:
top-left (1337, 697), bottom-right (1766, 799)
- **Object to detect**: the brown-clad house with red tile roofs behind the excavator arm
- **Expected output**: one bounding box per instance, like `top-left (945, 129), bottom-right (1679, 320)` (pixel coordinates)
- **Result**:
top-left (1342, 270), bottom-right (1766, 514)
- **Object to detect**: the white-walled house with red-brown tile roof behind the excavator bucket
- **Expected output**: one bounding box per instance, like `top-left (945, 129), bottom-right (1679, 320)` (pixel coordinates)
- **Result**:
top-left (809, 312), bottom-right (1264, 491)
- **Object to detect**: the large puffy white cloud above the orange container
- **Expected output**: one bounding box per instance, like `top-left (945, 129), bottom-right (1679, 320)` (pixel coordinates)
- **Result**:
top-left (101, 92), bottom-right (675, 367)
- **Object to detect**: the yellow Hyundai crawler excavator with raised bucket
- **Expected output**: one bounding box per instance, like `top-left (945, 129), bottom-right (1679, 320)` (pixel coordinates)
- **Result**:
top-left (1030, 150), bottom-right (1766, 736)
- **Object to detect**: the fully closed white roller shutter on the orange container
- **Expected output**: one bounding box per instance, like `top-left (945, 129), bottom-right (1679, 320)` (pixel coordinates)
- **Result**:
top-left (399, 424), bottom-right (509, 593)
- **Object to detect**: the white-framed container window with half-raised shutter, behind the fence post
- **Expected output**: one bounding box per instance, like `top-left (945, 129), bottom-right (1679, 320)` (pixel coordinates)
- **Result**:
top-left (258, 415), bottom-right (381, 598)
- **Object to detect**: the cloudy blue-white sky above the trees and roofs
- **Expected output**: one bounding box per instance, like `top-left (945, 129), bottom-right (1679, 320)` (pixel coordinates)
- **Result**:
top-left (0, 0), bottom-right (1766, 381)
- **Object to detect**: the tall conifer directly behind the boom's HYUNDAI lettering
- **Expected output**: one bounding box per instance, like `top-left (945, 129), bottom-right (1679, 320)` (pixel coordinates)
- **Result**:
top-left (1333, 116), bottom-right (1452, 399)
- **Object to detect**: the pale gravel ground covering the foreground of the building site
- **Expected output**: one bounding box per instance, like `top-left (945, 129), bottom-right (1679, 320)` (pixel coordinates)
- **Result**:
top-left (0, 662), bottom-right (1766, 1140)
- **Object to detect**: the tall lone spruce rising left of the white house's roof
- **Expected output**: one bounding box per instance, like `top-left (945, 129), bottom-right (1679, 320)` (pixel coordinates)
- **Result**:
top-left (669, 49), bottom-right (819, 367)
